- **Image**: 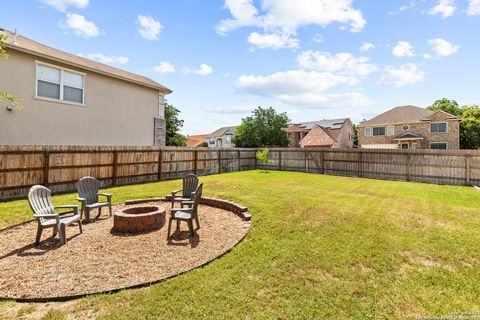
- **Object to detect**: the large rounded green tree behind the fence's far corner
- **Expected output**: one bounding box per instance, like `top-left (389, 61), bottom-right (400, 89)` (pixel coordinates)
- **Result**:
top-left (232, 107), bottom-right (290, 148)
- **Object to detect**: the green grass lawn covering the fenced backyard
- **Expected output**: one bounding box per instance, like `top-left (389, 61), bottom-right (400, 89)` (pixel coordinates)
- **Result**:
top-left (0, 171), bottom-right (480, 319)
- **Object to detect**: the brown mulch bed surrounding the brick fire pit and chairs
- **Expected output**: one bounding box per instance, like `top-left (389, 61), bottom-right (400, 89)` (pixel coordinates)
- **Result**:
top-left (0, 202), bottom-right (248, 299)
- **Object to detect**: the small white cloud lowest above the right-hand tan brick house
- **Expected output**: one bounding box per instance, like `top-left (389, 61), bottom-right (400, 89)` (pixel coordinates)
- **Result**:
top-left (378, 63), bottom-right (426, 88)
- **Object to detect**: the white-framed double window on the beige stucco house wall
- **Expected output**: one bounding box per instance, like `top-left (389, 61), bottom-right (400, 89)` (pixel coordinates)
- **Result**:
top-left (36, 63), bottom-right (85, 104)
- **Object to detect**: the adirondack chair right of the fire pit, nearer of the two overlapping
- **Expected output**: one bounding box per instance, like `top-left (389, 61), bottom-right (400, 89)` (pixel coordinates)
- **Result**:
top-left (167, 183), bottom-right (203, 240)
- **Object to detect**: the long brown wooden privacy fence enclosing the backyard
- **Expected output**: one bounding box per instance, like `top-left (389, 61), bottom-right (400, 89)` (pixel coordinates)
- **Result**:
top-left (0, 146), bottom-right (480, 199)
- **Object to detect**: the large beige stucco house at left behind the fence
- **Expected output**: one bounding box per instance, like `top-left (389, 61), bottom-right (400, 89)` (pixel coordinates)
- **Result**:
top-left (0, 30), bottom-right (172, 146)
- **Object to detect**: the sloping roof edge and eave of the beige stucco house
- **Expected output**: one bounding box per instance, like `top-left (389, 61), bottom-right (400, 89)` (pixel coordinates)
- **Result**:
top-left (0, 29), bottom-right (172, 94)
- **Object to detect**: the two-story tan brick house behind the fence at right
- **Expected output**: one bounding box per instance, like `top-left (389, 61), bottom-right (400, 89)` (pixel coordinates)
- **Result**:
top-left (358, 106), bottom-right (460, 150)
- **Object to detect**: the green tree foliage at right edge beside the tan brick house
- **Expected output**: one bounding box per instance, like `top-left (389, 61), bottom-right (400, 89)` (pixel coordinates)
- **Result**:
top-left (427, 98), bottom-right (480, 149)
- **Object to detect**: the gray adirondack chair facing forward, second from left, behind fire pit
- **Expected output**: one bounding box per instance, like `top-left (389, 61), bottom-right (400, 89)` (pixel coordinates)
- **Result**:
top-left (75, 177), bottom-right (112, 223)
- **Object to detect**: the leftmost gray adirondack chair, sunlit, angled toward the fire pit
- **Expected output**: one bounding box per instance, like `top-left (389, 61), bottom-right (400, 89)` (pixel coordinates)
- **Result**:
top-left (28, 185), bottom-right (83, 245)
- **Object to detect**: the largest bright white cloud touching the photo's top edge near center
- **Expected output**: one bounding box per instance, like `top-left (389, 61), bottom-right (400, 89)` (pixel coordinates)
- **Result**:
top-left (216, 0), bottom-right (367, 48)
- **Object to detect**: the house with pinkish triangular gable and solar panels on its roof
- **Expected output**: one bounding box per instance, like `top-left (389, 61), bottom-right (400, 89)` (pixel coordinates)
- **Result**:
top-left (284, 118), bottom-right (353, 148)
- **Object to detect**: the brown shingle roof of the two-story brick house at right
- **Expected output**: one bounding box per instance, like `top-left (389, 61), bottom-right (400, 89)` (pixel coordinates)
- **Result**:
top-left (360, 106), bottom-right (458, 126)
